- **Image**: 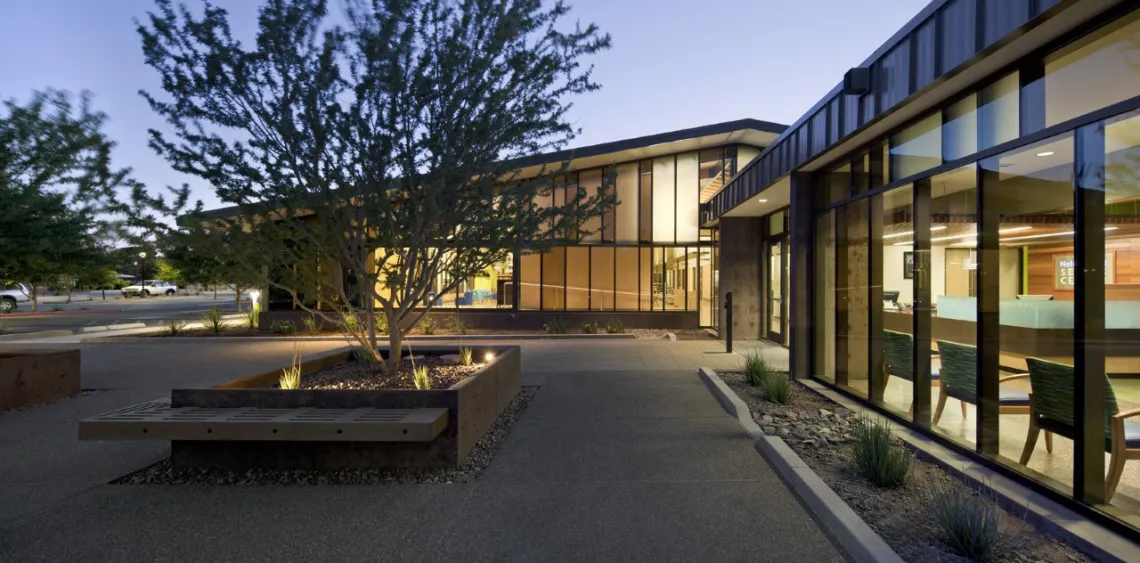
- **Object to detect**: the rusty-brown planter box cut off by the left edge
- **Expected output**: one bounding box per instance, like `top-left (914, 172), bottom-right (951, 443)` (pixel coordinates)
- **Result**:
top-left (0, 350), bottom-right (80, 410)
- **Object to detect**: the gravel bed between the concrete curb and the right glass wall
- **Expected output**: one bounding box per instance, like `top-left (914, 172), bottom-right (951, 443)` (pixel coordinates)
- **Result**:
top-left (718, 372), bottom-right (1094, 563)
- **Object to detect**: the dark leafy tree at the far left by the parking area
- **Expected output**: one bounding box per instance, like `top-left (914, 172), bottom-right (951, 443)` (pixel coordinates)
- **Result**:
top-left (0, 91), bottom-right (142, 310)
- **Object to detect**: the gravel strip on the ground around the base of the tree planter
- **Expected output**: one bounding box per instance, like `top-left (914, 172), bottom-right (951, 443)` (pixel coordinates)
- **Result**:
top-left (111, 386), bottom-right (538, 486)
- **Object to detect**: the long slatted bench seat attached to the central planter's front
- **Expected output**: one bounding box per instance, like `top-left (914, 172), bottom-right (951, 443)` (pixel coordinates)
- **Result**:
top-left (79, 399), bottom-right (448, 442)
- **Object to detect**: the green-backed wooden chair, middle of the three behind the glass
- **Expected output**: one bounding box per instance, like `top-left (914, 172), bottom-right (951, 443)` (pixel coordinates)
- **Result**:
top-left (934, 341), bottom-right (1035, 426)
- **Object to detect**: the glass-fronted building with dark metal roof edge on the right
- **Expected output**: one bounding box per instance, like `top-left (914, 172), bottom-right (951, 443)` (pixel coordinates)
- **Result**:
top-left (701, 0), bottom-right (1140, 537)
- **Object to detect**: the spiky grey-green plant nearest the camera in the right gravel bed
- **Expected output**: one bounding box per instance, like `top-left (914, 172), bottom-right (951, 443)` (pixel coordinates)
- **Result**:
top-left (925, 476), bottom-right (1000, 561)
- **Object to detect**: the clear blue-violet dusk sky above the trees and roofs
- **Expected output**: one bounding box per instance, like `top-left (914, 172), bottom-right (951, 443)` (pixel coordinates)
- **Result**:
top-left (0, 0), bottom-right (929, 209)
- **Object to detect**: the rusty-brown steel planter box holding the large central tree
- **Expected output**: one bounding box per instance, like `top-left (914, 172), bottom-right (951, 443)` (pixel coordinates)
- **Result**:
top-left (171, 346), bottom-right (521, 470)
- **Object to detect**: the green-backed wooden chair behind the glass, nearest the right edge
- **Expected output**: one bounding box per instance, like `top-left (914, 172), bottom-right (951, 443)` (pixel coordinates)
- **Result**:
top-left (1021, 358), bottom-right (1140, 503)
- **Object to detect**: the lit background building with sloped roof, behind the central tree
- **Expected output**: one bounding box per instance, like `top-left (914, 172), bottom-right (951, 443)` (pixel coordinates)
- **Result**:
top-left (256, 120), bottom-right (785, 328)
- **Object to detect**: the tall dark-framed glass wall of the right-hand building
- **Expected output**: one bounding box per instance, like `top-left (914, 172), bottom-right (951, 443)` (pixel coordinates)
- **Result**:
top-left (812, 6), bottom-right (1140, 527)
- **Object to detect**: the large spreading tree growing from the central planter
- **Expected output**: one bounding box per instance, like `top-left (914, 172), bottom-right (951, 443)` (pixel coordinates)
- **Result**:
top-left (138, 0), bottom-right (614, 372)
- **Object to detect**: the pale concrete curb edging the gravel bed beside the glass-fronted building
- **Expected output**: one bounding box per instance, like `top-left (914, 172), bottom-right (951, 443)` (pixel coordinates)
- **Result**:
top-left (699, 368), bottom-right (903, 563)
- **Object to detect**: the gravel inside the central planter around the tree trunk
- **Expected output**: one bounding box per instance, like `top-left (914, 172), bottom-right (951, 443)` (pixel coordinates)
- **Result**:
top-left (301, 356), bottom-right (483, 390)
